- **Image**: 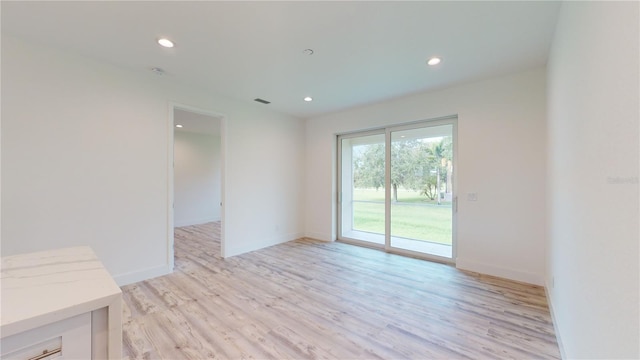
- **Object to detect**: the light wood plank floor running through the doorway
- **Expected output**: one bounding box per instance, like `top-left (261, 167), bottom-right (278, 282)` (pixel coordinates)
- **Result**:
top-left (122, 223), bottom-right (560, 359)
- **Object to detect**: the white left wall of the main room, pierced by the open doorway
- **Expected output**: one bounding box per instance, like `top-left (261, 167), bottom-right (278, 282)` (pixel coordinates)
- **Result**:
top-left (2, 32), bottom-right (304, 284)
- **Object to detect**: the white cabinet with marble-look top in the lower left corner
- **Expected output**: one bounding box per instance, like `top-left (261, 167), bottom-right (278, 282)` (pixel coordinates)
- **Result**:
top-left (0, 247), bottom-right (122, 360)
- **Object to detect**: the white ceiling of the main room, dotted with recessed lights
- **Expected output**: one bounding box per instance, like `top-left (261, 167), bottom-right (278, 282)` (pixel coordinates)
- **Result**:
top-left (1, 1), bottom-right (560, 118)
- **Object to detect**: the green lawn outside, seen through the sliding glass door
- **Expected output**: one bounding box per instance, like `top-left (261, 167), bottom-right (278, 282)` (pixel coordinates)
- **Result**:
top-left (353, 189), bottom-right (452, 245)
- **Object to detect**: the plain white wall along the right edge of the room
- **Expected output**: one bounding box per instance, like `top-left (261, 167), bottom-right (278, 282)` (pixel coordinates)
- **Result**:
top-left (547, 2), bottom-right (640, 359)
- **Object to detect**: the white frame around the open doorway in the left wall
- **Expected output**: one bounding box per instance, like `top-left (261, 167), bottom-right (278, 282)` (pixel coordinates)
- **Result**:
top-left (166, 102), bottom-right (227, 271)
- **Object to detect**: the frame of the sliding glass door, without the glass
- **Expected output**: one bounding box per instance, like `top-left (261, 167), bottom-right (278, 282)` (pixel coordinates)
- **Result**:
top-left (336, 115), bottom-right (459, 264)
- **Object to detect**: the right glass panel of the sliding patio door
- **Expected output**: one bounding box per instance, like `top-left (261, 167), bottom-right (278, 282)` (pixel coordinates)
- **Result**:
top-left (389, 124), bottom-right (454, 258)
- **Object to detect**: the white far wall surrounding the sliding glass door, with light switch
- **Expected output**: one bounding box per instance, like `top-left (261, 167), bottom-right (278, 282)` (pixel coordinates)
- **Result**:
top-left (306, 69), bottom-right (546, 284)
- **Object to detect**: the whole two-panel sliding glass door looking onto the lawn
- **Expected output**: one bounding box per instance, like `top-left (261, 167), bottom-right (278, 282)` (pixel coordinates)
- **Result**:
top-left (338, 118), bottom-right (456, 261)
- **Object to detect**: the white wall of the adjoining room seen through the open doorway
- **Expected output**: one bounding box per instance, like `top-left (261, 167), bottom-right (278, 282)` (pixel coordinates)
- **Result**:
top-left (173, 131), bottom-right (222, 226)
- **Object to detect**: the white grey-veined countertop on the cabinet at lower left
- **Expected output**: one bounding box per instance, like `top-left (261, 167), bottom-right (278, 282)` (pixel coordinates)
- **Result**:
top-left (0, 246), bottom-right (121, 337)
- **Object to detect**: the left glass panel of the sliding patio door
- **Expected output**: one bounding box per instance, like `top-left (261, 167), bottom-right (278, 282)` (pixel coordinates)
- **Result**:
top-left (339, 133), bottom-right (386, 245)
